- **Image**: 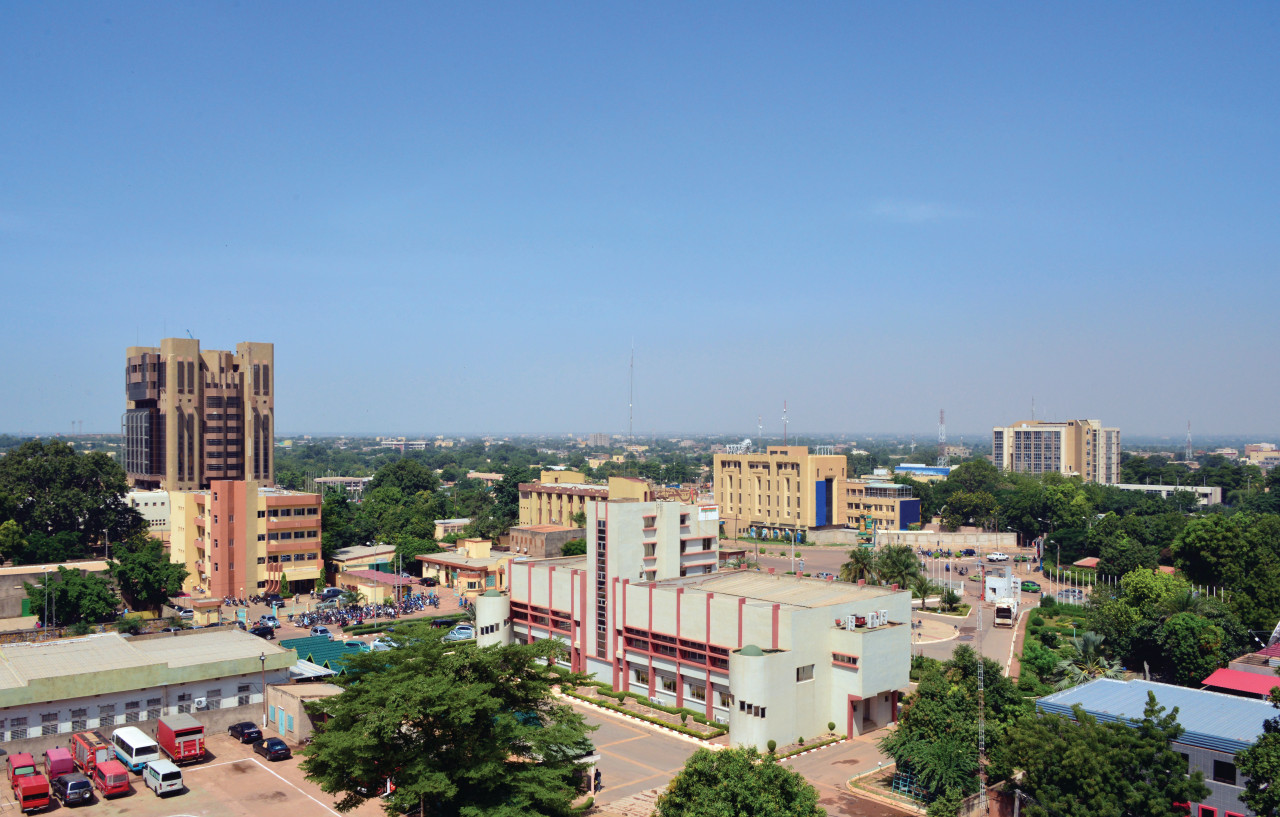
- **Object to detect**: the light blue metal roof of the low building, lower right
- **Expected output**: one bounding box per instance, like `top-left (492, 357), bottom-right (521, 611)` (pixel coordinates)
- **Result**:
top-left (1036, 679), bottom-right (1276, 754)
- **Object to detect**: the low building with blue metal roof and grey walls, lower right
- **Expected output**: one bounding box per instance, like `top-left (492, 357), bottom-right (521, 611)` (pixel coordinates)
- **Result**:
top-left (1036, 679), bottom-right (1275, 817)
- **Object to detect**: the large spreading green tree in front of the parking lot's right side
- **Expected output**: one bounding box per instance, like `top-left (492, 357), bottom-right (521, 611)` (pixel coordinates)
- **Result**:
top-left (302, 624), bottom-right (591, 817)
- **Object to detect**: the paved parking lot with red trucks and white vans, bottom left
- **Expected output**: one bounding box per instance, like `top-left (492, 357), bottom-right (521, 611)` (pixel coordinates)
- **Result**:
top-left (5, 734), bottom-right (383, 817)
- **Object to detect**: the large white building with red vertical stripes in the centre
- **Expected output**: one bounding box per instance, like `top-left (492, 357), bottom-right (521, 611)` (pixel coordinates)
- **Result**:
top-left (476, 501), bottom-right (910, 749)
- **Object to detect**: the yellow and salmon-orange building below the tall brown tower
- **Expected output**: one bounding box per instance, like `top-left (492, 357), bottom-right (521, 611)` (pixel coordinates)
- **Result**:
top-left (169, 480), bottom-right (323, 598)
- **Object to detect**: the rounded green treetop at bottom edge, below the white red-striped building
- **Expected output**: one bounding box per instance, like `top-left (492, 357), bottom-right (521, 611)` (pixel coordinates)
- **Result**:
top-left (654, 747), bottom-right (827, 817)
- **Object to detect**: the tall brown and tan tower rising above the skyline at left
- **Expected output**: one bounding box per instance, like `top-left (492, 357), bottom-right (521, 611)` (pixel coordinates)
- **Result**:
top-left (123, 338), bottom-right (275, 490)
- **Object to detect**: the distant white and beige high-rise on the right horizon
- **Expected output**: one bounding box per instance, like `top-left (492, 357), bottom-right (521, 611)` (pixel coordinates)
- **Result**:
top-left (991, 420), bottom-right (1120, 485)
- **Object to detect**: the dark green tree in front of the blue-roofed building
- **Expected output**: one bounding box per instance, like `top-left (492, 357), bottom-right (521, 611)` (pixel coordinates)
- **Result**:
top-left (1010, 694), bottom-right (1208, 817)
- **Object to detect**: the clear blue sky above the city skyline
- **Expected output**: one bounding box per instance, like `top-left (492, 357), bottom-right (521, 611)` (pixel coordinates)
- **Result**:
top-left (0, 3), bottom-right (1280, 435)
